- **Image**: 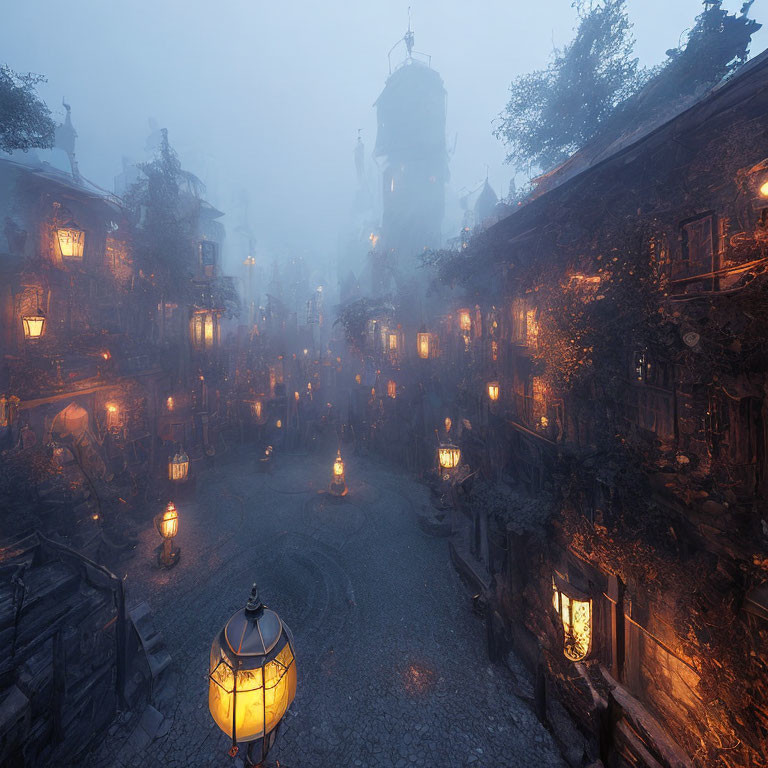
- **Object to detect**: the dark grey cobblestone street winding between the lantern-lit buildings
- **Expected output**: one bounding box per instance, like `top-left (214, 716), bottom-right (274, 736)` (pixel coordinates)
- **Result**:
top-left (88, 451), bottom-right (562, 768)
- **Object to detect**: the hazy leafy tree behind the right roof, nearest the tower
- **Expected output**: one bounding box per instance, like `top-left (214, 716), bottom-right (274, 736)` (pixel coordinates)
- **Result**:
top-left (494, 0), bottom-right (647, 170)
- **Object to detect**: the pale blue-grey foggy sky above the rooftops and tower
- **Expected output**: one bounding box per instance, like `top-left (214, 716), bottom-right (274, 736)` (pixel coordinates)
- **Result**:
top-left (0, 0), bottom-right (768, 272)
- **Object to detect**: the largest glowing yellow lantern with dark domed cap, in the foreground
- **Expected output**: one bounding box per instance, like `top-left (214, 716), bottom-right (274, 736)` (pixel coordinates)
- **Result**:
top-left (208, 584), bottom-right (296, 765)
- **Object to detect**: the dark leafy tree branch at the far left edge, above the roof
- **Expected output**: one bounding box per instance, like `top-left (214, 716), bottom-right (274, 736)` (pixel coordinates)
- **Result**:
top-left (0, 65), bottom-right (56, 152)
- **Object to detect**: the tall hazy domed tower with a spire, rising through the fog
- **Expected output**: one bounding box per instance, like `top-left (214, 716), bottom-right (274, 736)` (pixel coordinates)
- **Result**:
top-left (374, 22), bottom-right (448, 267)
